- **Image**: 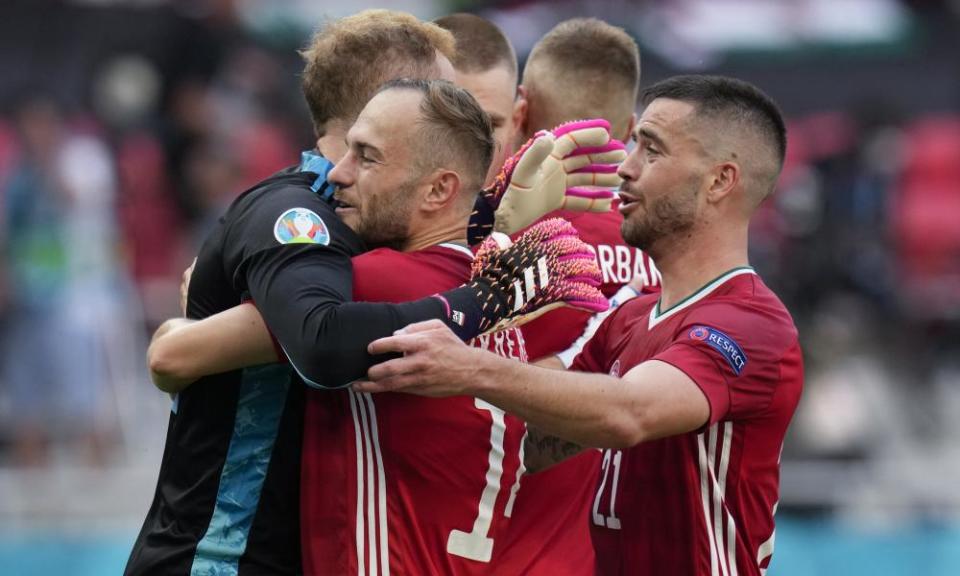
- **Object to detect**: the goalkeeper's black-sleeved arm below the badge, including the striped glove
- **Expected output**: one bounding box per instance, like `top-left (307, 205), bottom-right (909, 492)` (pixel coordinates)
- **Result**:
top-left (233, 200), bottom-right (607, 388)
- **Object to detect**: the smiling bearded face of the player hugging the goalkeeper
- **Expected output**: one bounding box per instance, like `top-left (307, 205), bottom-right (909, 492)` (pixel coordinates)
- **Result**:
top-left (329, 90), bottom-right (421, 248)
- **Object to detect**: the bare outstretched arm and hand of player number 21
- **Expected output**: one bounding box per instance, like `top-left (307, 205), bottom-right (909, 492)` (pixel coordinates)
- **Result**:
top-left (356, 323), bottom-right (710, 448)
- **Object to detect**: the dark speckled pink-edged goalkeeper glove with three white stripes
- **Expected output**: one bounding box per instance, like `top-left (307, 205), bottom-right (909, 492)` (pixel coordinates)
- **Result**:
top-left (470, 218), bottom-right (607, 333)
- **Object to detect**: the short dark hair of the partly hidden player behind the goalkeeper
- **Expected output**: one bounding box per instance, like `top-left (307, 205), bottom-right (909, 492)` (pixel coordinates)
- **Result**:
top-left (433, 12), bottom-right (517, 74)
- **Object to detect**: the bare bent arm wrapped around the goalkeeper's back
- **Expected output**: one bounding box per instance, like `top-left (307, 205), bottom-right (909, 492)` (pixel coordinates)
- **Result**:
top-left (147, 303), bottom-right (278, 393)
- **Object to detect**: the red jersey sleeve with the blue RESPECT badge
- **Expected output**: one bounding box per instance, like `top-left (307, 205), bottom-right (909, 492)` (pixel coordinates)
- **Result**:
top-left (653, 302), bottom-right (796, 425)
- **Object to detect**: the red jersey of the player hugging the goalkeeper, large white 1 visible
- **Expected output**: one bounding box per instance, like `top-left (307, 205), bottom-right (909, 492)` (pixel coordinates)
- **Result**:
top-left (301, 245), bottom-right (526, 576)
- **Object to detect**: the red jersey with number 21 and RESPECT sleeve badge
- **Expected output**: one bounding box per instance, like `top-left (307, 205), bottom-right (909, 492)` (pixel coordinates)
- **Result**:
top-left (572, 268), bottom-right (803, 576)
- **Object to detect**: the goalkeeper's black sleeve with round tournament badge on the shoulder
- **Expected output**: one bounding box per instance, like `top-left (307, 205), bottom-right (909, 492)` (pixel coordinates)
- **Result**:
top-left (224, 185), bottom-right (466, 388)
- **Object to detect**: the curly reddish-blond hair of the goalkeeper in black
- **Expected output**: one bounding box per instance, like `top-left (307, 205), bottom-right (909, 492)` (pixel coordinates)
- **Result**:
top-left (301, 10), bottom-right (456, 136)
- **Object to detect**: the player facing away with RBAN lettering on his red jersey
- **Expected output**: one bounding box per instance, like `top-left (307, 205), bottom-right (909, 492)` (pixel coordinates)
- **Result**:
top-left (520, 18), bottom-right (659, 360)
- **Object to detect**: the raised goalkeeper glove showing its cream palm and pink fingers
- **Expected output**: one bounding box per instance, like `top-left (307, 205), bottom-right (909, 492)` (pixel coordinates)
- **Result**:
top-left (484, 120), bottom-right (626, 234)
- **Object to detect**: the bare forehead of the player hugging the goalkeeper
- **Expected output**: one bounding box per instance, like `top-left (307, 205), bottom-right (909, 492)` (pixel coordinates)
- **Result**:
top-left (347, 90), bottom-right (422, 149)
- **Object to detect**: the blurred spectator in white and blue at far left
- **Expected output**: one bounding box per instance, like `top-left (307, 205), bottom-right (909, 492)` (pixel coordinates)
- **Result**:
top-left (3, 98), bottom-right (115, 465)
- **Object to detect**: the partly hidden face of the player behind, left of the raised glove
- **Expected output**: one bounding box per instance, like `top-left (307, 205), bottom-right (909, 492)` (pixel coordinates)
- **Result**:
top-left (457, 66), bottom-right (517, 186)
